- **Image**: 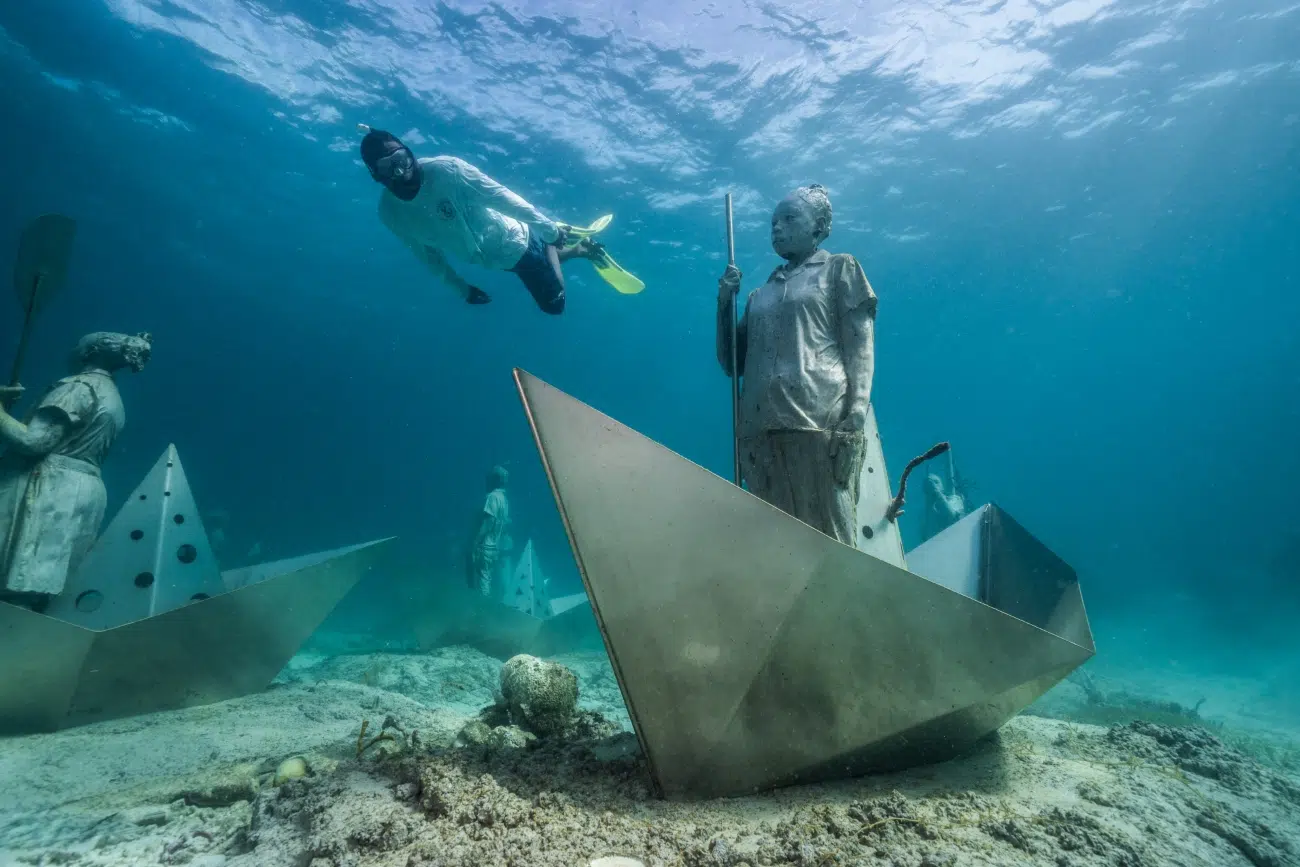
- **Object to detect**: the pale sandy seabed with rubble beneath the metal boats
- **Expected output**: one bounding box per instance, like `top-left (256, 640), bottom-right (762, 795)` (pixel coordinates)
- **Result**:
top-left (0, 647), bottom-right (1300, 867)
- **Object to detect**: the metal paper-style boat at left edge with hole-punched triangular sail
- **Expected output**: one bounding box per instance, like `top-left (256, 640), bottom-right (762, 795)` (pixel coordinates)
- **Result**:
top-left (0, 446), bottom-right (386, 733)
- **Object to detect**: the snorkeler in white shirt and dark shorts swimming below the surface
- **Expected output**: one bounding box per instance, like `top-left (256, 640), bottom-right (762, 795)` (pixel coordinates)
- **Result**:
top-left (361, 127), bottom-right (605, 316)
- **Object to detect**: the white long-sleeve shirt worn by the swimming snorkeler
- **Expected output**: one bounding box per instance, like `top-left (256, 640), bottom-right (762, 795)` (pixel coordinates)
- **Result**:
top-left (380, 156), bottom-right (559, 299)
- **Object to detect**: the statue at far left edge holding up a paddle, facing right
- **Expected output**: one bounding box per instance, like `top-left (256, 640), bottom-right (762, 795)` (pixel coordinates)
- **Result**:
top-left (0, 331), bottom-right (152, 608)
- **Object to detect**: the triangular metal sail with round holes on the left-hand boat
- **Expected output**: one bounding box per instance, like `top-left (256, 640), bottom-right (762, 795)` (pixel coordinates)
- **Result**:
top-left (46, 445), bottom-right (225, 629)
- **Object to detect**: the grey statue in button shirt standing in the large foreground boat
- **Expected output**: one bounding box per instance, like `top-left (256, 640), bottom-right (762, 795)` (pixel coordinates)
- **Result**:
top-left (718, 183), bottom-right (876, 547)
